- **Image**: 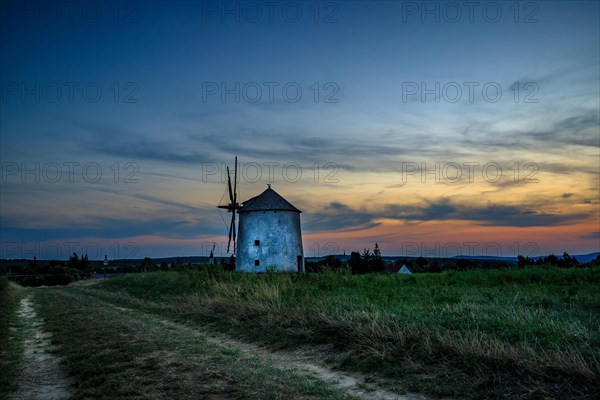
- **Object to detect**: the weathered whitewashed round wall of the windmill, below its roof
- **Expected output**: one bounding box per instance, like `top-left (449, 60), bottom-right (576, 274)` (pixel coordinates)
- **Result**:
top-left (235, 211), bottom-right (304, 272)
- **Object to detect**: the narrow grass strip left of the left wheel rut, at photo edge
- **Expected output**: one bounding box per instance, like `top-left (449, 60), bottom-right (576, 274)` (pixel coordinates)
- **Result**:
top-left (0, 277), bottom-right (24, 399)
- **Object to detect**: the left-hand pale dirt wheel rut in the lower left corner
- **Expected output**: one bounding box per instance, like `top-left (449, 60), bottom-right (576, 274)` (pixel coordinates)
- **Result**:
top-left (9, 296), bottom-right (70, 400)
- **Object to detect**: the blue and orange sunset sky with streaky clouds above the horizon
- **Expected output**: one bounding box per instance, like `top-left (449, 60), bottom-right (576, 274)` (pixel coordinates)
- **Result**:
top-left (0, 1), bottom-right (600, 259)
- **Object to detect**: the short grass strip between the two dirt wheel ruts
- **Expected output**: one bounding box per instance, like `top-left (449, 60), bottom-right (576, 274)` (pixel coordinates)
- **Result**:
top-left (34, 286), bottom-right (347, 399)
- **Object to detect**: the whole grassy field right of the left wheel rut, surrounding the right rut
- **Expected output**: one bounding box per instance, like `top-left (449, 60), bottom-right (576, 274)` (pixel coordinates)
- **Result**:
top-left (1, 268), bottom-right (600, 399)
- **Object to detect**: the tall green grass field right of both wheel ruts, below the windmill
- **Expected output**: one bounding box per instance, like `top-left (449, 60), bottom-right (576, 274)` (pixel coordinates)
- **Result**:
top-left (86, 268), bottom-right (600, 398)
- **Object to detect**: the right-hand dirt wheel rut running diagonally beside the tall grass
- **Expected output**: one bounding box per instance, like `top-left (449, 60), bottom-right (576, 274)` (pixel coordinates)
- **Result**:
top-left (112, 304), bottom-right (429, 400)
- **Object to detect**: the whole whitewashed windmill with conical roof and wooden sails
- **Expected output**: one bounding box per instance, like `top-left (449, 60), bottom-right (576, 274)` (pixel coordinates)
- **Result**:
top-left (219, 157), bottom-right (304, 272)
